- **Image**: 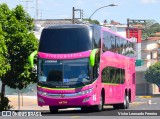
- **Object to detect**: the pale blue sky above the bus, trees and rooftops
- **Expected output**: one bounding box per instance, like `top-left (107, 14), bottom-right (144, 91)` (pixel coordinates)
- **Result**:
top-left (0, 0), bottom-right (160, 24)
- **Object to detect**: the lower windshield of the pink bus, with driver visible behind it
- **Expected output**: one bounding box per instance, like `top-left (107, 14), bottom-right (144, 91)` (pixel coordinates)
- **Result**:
top-left (38, 58), bottom-right (91, 87)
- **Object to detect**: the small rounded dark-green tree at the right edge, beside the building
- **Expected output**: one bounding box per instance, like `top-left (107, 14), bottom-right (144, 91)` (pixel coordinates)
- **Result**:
top-left (145, 62), bottom-right (160, 87)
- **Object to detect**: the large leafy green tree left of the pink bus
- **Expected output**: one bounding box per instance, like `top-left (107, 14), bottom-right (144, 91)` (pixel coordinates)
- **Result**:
top-left (0, 4), bottom-right (38, 110)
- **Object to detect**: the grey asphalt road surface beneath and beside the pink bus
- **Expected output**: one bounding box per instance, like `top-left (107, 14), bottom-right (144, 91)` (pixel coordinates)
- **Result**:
top-left (0, 97), bottom-right (160, 119)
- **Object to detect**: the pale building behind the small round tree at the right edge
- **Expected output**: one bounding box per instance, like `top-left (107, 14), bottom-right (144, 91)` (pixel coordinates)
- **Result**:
top-left (136, 37), bottom-right (160, 95)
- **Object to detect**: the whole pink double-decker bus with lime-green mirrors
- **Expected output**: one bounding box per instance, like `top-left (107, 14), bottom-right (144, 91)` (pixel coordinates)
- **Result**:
top-left (31, 24), bottom-right (135, 113)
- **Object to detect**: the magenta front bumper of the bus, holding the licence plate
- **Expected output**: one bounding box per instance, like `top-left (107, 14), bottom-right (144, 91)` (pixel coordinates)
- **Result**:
top-left (38, 93), bottom-right (97, 107)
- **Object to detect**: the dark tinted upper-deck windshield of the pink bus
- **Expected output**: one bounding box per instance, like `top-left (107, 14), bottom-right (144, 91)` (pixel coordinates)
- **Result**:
top-left (39, 27), bottom-right (92, 54)
